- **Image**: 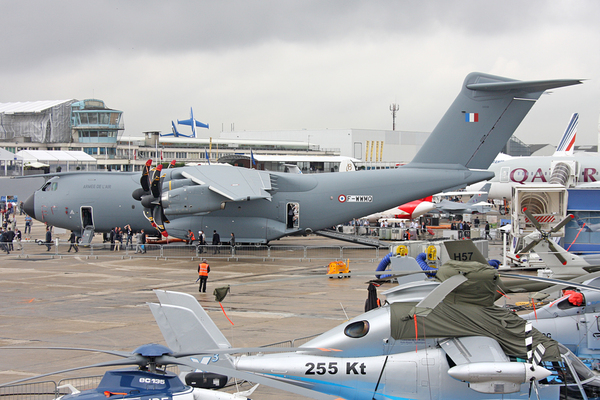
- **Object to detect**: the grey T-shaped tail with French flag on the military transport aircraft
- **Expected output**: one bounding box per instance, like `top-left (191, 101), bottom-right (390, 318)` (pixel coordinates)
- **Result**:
top-left (407, 72), bottom-right (581, 169)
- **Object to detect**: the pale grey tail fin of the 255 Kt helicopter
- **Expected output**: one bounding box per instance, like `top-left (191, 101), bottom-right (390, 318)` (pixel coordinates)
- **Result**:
top-left (148, 290), bottom-right (232, 368)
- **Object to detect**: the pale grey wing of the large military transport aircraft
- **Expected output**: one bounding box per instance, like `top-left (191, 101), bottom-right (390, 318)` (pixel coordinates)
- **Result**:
top-left (182, 165), bottom-right (272, 201)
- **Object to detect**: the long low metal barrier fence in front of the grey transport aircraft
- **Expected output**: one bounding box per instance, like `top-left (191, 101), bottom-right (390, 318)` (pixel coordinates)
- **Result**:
top-left (11, 242), bottom-right (389, 261)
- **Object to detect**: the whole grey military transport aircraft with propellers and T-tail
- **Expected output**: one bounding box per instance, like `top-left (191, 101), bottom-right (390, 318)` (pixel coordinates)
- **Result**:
top-left (24, 73), bottom-right (581, 243)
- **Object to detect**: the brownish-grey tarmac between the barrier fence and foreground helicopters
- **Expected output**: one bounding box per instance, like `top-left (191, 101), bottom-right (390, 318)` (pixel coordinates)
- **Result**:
top-left (0, 224), bottom-right (506, 399)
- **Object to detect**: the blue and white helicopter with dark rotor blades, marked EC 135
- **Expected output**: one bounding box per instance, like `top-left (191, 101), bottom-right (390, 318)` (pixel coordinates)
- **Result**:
top-left (0, 343), bottom-right (350, 400)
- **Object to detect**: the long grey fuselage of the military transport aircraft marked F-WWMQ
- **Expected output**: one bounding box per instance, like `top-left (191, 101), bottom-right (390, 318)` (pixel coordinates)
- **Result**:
top-left (26, 166), bottom-right (490, 243)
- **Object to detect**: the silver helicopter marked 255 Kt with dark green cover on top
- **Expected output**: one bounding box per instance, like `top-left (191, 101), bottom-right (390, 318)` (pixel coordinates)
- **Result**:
top-left (149, 261), bottom-right (600, 399)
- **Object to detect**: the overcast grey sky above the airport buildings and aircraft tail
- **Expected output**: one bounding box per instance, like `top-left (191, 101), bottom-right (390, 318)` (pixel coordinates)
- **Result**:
top-left (0, 0), bottom-right (600, 144)
